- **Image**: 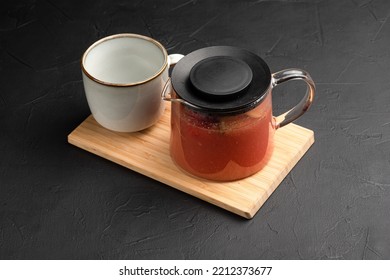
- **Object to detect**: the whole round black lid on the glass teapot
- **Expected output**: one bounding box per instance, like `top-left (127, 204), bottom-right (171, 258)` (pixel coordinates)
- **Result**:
top-left (171, 46), bottom-right (271, 112)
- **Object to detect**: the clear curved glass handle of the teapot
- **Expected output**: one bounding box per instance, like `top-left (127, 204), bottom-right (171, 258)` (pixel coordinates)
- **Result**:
top-left (271, 68), bottom-right (316, 129)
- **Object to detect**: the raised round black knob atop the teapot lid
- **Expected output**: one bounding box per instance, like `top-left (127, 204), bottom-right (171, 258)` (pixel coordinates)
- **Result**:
top-left (190, 56), bottom-right (253, 101)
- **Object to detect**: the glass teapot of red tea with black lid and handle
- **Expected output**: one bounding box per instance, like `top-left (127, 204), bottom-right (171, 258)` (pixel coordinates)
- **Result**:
top-left (163, 46), bottom-right (315, 181)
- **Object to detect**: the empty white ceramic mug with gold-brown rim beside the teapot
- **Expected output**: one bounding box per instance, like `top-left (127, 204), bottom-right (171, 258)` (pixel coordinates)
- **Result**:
top-left (81, 33), bottom-right (183, 132)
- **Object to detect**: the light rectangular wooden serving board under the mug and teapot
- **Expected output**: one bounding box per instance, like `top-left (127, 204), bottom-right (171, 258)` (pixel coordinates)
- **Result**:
top-left (68, 104), bottom-right (314, 219)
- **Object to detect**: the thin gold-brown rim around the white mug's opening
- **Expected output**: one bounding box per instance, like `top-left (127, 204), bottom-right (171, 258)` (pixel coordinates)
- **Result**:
top-left (81, 33), bottom-right (168, 87)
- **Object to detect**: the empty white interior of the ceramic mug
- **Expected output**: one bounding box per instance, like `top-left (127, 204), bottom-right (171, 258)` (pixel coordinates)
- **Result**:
top-left (82, 34), bottom-right (167, 85)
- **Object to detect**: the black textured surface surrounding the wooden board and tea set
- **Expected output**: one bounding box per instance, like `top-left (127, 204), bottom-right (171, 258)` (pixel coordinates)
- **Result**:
top-left (0, 0), bottom-right (390, 259)
